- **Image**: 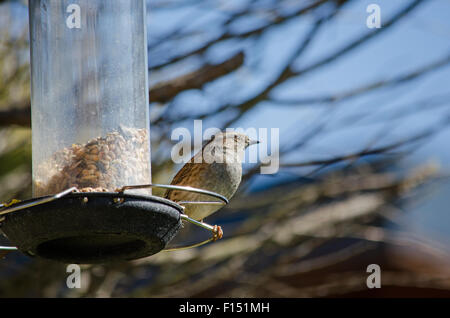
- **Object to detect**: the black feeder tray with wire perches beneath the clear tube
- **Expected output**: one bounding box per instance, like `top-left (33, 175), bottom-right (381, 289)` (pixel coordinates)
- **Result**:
top-left (0, 184), bottom-right (228, 264)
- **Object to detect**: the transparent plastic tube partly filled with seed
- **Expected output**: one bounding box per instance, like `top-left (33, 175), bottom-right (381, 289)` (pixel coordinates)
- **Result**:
top-left (29, 0), bottom-right (151, 196)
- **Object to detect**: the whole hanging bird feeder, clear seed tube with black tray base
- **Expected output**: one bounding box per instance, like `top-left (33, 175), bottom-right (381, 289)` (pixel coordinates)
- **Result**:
top-left (0, 0), bottom-right (227, 263)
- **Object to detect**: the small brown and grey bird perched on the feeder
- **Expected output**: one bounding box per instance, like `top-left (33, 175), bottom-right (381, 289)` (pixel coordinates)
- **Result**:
top-left (165, 131), bottom-right (259, 240)
